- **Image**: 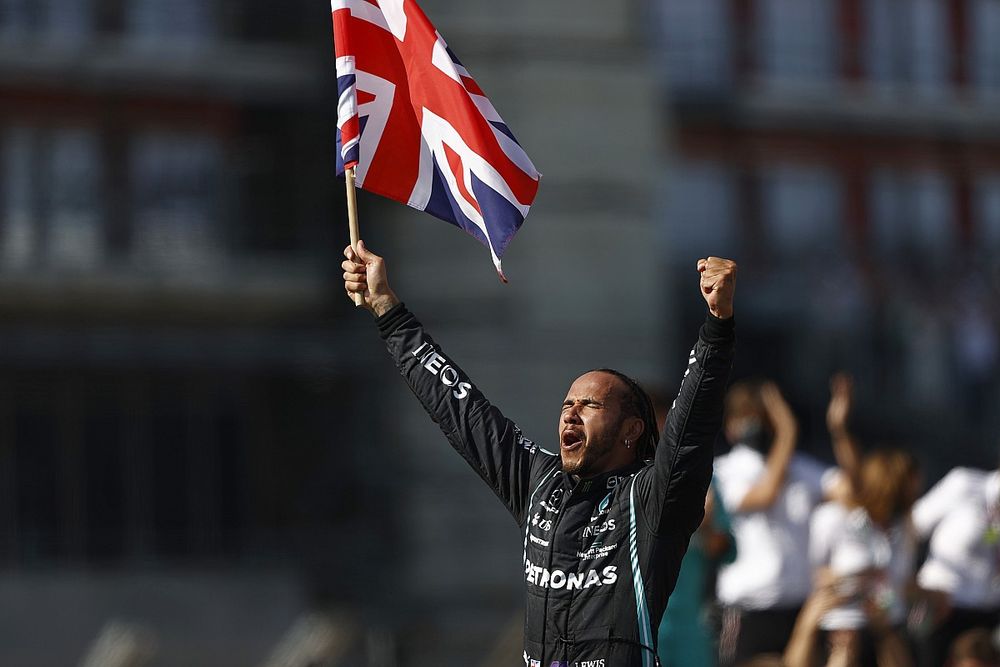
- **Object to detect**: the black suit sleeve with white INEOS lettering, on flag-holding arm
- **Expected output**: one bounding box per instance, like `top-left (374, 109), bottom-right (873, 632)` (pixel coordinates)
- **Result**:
top-left (377, 304), bottom-right (558, 525)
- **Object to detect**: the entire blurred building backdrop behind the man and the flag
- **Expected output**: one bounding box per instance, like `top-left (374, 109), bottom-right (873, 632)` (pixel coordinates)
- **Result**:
top-left (0, 0), bottom-right (1000, 667)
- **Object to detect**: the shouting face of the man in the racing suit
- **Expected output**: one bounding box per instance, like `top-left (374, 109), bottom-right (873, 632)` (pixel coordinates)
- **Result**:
top-left (559, 372), bottom-right (635, 477)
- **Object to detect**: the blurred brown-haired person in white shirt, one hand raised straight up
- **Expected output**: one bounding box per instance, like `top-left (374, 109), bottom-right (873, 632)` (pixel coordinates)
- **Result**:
top-left (809, 375), bottom-right (920, 665)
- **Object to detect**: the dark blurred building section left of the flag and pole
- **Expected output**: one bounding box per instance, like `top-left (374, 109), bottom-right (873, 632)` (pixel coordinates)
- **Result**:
top-left (0, 0), bottom-right (398, 665)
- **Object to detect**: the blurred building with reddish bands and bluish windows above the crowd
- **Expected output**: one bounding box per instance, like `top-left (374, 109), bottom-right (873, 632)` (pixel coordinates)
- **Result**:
top-left (655, 0), bottom-right (1000, 474)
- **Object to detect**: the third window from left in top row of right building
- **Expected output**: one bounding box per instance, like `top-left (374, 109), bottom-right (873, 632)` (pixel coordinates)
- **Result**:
top-left (864, 0), bottom-right (950, 97)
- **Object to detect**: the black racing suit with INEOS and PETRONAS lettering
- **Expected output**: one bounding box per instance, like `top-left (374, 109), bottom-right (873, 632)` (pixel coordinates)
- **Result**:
top-left (378, 304), bottom-right (734, 667)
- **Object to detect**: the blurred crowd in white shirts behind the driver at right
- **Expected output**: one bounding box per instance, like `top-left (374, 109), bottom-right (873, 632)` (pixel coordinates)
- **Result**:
top-left (659, 374), bottom-right (1000, 667)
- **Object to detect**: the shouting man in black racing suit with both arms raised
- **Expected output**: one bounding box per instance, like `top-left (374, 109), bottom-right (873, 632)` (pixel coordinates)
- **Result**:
top-left (343, 243), bottom-right (736, 667)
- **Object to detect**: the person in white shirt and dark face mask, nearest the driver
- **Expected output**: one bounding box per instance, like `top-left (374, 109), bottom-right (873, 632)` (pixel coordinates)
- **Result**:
top-left (715, 382), bottom-right (837, 665)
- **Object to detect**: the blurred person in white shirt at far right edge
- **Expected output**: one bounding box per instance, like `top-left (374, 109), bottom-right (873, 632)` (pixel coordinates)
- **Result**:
top-left (913, 468), bottom-right (1000, 667)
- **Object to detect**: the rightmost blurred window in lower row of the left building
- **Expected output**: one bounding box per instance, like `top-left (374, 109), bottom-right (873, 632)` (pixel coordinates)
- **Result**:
top-left (130, 133), bottom-right (222, 271)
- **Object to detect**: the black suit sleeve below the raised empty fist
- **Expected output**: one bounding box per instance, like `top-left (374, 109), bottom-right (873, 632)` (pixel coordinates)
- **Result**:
top-left (637, 315), bottom-right (736, 535)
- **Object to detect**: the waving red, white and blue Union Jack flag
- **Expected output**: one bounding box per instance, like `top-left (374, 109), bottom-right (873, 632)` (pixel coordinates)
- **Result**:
top-left (332, 0), bottom-right (540, 282)
